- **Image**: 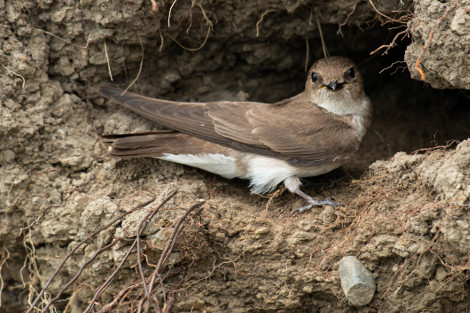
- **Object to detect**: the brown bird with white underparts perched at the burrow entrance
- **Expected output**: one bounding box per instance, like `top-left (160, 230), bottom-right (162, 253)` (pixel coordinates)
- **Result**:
top-left (99, 57), bottom-right (372, 213)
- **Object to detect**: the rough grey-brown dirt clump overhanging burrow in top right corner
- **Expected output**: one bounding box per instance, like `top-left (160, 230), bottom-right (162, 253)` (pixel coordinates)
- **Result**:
top-left (405, 0), bottom-right (470, 90)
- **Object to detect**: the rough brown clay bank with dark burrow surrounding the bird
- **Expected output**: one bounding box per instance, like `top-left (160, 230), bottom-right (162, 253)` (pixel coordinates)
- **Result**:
top-left (0, 0), bottom-right (470, 312)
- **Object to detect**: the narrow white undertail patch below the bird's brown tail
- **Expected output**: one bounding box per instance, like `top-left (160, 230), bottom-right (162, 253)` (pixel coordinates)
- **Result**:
top-left (159, 153), bottom-right (243, 178)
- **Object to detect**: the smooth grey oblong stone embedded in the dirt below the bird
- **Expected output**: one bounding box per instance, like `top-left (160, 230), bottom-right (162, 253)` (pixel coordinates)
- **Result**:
top-left (339, 256), bottom-right (376, 306)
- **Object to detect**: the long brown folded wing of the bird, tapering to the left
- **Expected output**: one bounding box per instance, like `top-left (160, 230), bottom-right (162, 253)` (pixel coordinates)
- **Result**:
top-left (99, 86), bottom-right (359, 166)
